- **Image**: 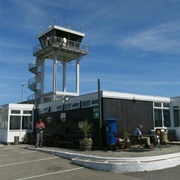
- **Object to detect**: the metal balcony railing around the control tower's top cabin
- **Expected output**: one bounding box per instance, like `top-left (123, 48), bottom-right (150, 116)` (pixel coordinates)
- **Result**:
top-left (33, 36), bottom-right (88, 54)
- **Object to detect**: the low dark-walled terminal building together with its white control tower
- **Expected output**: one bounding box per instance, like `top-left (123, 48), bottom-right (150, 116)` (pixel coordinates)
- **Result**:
top-left (0, 25), bottom-right (180, 147)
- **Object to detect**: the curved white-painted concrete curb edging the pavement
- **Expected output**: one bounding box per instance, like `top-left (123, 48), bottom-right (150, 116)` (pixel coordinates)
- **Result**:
top-left (27, 147), bottom-right (180, 172)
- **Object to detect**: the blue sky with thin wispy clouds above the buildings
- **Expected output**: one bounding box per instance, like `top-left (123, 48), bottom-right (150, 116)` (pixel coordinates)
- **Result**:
top-left (0, 0), bottom-right (180, 105)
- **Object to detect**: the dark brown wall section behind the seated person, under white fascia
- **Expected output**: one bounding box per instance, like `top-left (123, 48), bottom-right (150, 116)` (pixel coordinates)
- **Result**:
top-left (103, 98), bottom-right (153, 135)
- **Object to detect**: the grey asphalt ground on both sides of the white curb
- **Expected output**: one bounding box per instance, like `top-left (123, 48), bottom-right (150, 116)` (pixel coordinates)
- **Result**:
top-left (0, 144), bottom-right (180, 180)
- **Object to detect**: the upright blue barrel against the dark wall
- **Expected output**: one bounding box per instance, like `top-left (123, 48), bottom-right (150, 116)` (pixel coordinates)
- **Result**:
top-left (106, 118), bottom-right (116, 145)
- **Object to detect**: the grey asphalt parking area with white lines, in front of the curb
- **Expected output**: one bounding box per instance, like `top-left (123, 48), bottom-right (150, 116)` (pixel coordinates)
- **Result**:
top-left (0, 145), bottom-right (180, 180)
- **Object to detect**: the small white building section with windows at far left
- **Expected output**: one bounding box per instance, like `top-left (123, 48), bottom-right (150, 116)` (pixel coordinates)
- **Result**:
top-left (0, 104), bottom-right (34, 144)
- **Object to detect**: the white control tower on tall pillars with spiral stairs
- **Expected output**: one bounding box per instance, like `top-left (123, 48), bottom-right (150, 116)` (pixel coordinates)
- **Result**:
top-left (28, 25), bottom-right (88, 105)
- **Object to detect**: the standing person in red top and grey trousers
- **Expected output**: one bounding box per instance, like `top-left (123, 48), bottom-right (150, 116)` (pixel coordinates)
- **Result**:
top-left (36, 119), bottom-right (45, 148)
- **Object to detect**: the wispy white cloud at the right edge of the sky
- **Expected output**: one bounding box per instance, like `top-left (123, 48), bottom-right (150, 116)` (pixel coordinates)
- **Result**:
top-left (120, 22), bottom-right (180, 54)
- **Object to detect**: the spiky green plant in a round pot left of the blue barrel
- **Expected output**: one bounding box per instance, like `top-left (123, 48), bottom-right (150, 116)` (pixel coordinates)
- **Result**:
top-left (79, 120), bottom-right (93, 150)
